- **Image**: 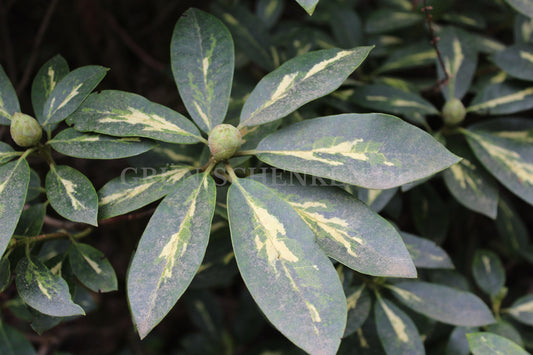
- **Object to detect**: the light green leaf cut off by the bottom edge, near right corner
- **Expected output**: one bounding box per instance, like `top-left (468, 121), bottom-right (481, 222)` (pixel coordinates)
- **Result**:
top-left (466, 332), bottom-right (529, 355)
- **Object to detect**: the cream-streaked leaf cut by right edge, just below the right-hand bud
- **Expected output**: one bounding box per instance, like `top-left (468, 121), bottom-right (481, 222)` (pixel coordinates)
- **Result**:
top-left (464, 118), bottom-right (533, 204)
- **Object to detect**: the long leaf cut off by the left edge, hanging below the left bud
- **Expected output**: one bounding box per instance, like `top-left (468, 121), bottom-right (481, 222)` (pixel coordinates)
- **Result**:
top-left (0, 159), bottom-right (30, 256)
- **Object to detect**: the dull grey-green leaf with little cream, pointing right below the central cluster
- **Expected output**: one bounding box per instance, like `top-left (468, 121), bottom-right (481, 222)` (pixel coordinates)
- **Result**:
top-left (387, 281), bottom-right (495, 327)
